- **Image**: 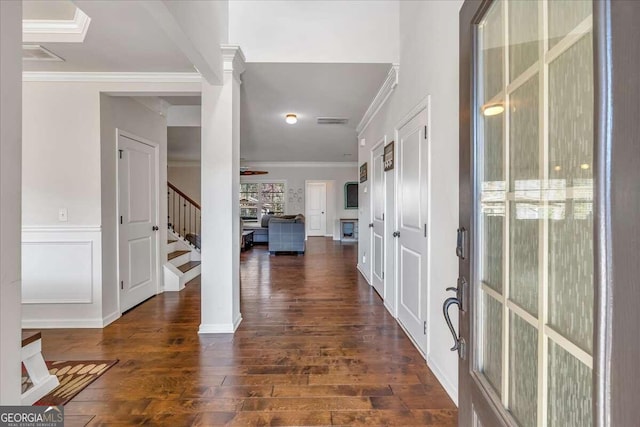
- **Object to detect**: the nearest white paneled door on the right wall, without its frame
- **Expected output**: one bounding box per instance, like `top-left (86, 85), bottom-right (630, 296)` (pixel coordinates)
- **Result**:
top-left (397, 109), bottom-right (428, 353)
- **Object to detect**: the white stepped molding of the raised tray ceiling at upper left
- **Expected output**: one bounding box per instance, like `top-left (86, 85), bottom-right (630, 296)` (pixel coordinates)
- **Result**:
top-left (22, 8), bottom-right (91, 43)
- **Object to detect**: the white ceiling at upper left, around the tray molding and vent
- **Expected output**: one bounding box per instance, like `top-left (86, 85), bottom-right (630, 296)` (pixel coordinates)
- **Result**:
top-left (23, 0), bottom-right (195, 72)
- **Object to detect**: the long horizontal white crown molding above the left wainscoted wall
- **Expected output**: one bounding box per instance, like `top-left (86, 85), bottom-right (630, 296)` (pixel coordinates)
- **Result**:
top-left (22, 71), bottom-right (202, 83)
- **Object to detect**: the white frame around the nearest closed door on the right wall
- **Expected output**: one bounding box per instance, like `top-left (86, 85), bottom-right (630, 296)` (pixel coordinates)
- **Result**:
top-left (393, 95), bottom-right (432, 360)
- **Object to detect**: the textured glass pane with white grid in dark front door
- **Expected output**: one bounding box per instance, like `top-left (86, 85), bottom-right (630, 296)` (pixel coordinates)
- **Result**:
top-left (472, 0), bottom-right (594, 427)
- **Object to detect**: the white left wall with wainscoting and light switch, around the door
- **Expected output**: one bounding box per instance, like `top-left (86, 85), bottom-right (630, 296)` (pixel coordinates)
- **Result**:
top-left (22, 77), bottom-right (200, 328)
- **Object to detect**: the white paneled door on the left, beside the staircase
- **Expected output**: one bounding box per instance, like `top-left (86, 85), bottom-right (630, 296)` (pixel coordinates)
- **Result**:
top-left (118, 135), bottom-right (158, 312)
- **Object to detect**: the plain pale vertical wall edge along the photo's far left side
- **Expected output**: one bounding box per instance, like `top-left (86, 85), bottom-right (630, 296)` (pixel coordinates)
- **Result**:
top-left (0, 1), bottom-right (22, 405)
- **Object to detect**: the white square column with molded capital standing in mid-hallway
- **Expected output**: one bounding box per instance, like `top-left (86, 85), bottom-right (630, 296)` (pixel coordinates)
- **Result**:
top-left (199, 46), bottom-right (244, 334)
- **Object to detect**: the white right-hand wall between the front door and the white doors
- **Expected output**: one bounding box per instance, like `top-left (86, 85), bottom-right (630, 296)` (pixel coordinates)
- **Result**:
top-left (359, 0), bottom-right (462, 401)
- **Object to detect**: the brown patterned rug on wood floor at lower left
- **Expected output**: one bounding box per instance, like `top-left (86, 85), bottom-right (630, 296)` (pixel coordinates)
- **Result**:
top-left (22, 360), bottom-right (118, 406)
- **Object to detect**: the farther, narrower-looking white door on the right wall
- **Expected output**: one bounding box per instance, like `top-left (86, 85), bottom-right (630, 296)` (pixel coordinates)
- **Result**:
top-left (369, 144), bottom-right (385, 299)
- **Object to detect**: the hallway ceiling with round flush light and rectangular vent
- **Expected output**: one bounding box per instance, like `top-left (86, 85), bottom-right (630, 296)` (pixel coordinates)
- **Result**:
top-left (240, 63), bottom-right (390, 162)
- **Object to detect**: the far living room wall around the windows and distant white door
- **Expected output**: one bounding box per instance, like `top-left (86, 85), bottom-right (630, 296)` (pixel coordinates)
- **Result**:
top-left (241, 162), bottom-right (358, 240)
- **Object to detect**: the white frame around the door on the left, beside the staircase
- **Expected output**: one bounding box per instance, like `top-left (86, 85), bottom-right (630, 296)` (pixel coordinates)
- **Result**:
top-left (114, 128), bottom-right (164, 313)
